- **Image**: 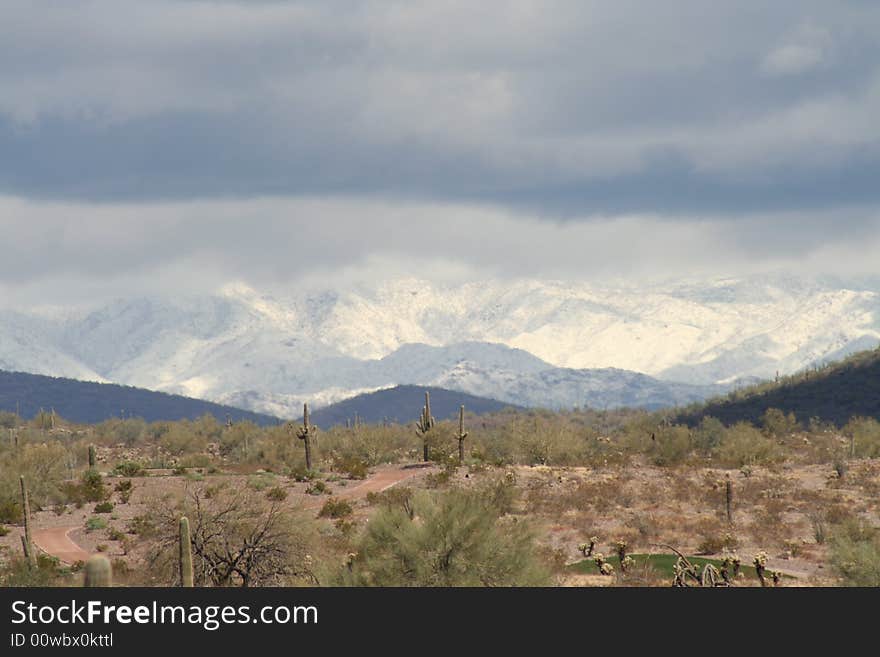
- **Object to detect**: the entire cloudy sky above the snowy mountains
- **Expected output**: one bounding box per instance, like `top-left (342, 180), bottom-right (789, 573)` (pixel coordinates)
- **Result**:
top-left (0, 0), bottom-right (880, 302)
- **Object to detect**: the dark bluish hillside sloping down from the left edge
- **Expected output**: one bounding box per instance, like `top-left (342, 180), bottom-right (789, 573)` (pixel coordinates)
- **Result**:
top-left (0, 370), bottom-right (278, 425)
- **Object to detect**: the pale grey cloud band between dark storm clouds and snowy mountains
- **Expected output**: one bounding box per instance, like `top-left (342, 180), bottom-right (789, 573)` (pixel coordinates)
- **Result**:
top-left (0, 193), bottom-right (880, 306)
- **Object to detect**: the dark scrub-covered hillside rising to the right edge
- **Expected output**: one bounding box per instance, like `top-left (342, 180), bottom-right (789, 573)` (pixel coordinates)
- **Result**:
top-left (681, 349), bottom-right (880, 426)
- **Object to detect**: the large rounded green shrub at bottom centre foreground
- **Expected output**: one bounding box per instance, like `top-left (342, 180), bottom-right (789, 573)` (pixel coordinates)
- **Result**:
top-left (338, 490), bottom-right (551, 587)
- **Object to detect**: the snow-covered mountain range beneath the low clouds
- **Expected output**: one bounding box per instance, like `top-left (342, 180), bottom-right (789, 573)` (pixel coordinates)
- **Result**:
top-left (0, 276), bottom-right (880, 416)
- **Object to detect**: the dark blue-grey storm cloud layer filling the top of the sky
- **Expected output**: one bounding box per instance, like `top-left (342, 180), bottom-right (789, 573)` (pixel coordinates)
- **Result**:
top-left (0, 0), bottom-right (880, 215)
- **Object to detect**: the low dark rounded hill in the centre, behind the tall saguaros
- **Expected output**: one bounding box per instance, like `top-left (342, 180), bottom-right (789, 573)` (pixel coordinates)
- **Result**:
top-left (302, 386), bottom-right (516, 429)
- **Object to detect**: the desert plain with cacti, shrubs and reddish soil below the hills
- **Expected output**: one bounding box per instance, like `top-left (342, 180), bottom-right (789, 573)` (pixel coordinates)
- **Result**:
top-left (0, 356), bottom-right (880, 588)
